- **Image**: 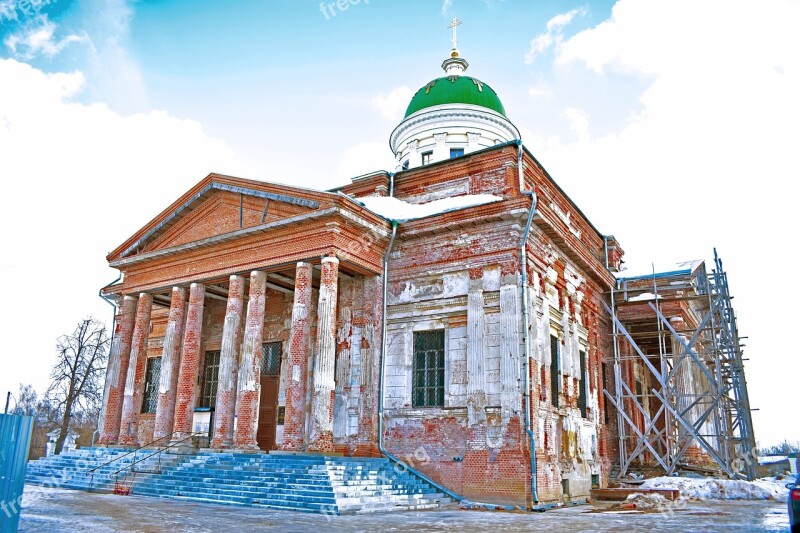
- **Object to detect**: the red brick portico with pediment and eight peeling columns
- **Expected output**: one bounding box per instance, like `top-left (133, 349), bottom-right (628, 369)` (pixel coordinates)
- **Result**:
top-left (100, 175), bottom-right (389, 452)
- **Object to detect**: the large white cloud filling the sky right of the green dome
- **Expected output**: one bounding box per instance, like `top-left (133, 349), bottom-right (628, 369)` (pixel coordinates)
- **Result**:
top-left (526, 0), bottom-right (800, 443)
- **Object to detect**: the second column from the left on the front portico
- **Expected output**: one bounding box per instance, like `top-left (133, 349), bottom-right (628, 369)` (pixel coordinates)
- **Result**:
top-left (118, 292), bottom-right (153, 446)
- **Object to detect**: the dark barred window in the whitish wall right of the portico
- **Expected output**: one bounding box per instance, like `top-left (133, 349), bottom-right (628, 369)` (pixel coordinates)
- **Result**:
top-left (411, 329), bottom-right (444, 407)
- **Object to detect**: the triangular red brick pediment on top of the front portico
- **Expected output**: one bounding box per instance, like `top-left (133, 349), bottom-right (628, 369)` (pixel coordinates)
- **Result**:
top-left (108, 174), bottom-right (331, 260)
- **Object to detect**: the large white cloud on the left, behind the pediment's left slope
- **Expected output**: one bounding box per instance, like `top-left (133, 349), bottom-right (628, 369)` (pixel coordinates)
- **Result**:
top-left (0, 59), bottom-right (252, 391)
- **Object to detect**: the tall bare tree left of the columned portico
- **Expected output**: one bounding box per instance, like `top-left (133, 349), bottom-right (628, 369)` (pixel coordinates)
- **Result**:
top-left (47, 318), bottom-right (109, 454)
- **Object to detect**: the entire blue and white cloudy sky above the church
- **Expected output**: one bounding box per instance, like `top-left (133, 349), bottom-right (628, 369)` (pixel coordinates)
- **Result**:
top-left (0, 0), bottom-right (800, 445)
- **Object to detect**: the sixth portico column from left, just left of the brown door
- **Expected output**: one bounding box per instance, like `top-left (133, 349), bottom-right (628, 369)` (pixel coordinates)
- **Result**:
top-left (234, 272), bottom-right (267, 450)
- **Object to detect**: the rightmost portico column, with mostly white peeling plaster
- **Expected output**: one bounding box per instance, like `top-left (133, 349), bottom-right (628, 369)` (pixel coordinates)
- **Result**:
top-left (308, 257), bottom-right (339, 452)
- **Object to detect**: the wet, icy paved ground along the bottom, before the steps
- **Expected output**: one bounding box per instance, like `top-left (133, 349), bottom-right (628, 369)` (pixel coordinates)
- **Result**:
top-left (20, 486), bottom-right (789, 533)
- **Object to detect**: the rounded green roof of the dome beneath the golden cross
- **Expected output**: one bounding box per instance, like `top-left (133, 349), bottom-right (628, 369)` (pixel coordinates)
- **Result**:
top-left (406, 76), bottom-right (506, 117)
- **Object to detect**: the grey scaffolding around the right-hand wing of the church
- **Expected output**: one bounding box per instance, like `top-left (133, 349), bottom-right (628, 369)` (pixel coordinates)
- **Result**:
top-left (603, 249), bottom-right (758, 480)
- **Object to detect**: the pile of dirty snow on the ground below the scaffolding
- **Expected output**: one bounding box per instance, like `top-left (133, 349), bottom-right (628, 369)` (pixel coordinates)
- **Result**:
top-left (641, 477), bottom-right (788, 500)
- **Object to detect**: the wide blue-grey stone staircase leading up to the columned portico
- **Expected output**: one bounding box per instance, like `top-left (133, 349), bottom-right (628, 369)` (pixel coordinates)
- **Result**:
top-left (26, 448), bottom-right (451, 515)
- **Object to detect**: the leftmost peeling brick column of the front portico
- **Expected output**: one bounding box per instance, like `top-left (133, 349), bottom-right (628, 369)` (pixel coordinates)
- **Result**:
top-left (98, 296), bottom-right (137, 444)
